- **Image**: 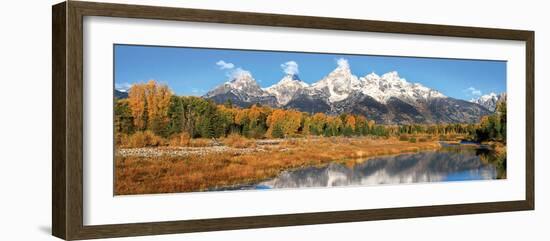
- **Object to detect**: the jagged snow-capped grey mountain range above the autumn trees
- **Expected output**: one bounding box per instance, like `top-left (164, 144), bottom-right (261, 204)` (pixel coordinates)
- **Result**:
top-left (203, 65), bottom-right (505, 124)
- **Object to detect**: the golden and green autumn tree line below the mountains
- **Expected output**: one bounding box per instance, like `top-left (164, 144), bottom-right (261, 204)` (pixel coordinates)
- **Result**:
top-left (114, 81), bottom-right (506, 141)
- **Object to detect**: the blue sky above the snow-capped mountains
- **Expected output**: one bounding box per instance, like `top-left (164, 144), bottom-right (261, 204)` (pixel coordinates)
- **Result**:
top-left (114, 45), bottom-right (506, 100)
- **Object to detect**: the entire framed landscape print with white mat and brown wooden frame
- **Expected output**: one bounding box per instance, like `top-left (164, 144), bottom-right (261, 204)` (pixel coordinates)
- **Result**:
top-left (52, 1), bottom-right (534, 240)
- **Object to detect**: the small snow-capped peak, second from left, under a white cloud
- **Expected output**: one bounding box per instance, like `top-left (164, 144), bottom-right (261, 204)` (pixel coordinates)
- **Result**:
top-left (264, 74), bottom-right (309, 105)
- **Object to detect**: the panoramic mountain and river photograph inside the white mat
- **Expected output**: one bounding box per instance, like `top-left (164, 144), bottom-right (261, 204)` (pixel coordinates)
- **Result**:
top-left (113, 44), bottom-right (507, 195)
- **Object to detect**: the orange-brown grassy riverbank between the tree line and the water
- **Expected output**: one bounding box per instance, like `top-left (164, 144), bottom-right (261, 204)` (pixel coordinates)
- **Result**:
top-left (115, 137), bottom-right (440, 195)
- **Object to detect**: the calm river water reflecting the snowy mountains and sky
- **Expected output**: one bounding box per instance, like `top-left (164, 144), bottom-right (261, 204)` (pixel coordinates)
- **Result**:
top-left (237, 145), bottom-right (506, 189)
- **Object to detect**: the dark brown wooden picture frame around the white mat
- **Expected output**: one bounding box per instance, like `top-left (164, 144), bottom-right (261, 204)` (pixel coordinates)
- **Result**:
top-left (52, 1), bottom-right (535, 240)
